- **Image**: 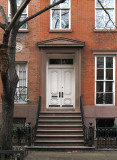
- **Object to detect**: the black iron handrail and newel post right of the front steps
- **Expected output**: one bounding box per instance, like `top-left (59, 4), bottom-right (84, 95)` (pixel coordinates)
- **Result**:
top-left (80, 96), bottom-right (94, 147)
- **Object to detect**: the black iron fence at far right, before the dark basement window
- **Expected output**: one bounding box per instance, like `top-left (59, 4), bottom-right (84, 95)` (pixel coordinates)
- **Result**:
top-left (96, 127), bottom-right (117, 148)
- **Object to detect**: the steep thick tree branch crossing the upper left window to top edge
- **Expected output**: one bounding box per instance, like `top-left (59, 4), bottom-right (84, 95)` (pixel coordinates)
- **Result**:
top-left (6, 0), bottom-right (30, 31)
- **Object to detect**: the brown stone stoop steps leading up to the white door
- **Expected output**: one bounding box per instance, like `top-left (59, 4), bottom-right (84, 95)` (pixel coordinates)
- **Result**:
top-left (29, 111), bottom-right (94, 151)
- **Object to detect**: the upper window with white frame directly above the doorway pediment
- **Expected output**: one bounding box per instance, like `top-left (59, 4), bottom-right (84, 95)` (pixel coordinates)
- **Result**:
top-left (51, 0), bottom-right (70, 29)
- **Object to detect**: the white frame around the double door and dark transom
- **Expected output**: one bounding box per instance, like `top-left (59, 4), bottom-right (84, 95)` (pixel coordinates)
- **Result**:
top-left (46, 54), bottom-right (75, 109)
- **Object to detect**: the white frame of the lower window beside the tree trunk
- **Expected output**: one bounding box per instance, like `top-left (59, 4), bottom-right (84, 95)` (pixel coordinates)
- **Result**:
top-left (15, 62), bottom-right (28, 104)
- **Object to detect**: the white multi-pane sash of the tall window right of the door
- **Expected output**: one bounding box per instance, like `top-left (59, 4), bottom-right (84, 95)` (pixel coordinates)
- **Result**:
top-left (95, 55), bottom-right (115, 105)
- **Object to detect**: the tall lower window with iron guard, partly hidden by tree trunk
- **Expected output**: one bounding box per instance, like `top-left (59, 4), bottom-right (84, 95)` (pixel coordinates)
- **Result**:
top-left (15, 63), bottom-right (27, 103)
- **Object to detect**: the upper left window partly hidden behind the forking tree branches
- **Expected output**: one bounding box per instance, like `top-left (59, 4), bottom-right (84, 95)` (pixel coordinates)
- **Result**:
top-left (8, 0), bottom-right (28, 29)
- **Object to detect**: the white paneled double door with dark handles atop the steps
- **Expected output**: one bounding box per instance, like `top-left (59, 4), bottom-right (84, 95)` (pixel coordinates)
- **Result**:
top-left (48, 68), bottom-right (74, 108)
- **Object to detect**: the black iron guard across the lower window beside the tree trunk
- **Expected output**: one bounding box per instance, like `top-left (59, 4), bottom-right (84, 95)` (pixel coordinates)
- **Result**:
top-left (14, 87), bottom-right (27, 102)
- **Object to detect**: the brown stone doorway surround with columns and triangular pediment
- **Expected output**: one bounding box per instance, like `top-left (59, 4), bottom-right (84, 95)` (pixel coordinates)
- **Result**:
top-left (37, 37), bottom-right (85, 111)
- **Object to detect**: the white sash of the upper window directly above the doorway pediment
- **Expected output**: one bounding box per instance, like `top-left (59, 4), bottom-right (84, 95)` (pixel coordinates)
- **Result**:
top-left (50, 0), bottom-right (71, 30)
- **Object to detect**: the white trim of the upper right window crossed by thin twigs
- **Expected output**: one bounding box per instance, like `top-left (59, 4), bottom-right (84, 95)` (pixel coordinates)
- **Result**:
top-left (95, 0), bottom-right (116, 29)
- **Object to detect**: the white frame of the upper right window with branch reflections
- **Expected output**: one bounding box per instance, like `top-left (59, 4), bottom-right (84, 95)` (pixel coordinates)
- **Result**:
top-left (95, 0), bottom-right (116, 29)
